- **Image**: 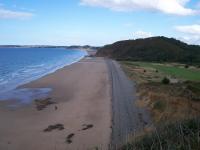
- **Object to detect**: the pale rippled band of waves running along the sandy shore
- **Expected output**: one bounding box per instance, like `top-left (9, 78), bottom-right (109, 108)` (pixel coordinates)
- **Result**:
top-left (0, 50), bottom-right (87, 95)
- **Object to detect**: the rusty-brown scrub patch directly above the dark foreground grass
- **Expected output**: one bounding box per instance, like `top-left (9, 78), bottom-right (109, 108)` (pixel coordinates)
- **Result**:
top-left (137, 84), bottom-right (200, 123)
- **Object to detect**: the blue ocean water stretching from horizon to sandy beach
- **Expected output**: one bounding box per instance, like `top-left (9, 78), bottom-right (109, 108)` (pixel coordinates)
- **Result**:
top-left (0, 48), bottom-right (87, 100)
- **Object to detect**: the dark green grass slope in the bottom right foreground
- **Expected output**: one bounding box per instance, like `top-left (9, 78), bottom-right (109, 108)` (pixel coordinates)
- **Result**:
top-left (122, 119), bottom-right (200, 150)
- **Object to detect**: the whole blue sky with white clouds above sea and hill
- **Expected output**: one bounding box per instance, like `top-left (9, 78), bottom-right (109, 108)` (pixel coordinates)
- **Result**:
top-left (0, 0), bottom-right (200, 46)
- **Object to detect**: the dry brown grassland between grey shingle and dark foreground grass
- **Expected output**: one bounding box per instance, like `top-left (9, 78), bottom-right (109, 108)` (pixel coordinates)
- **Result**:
top-left (122, 63), bottom-right (200, 124)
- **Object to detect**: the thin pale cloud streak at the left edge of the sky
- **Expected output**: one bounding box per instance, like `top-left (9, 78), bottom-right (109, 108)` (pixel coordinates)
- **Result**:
top-left (0, 7), bottom-right (34, 19)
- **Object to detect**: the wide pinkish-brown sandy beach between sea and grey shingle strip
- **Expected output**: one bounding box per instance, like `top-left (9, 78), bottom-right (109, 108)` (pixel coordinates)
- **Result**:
top-left (0, 58), bottom-right (111, 150)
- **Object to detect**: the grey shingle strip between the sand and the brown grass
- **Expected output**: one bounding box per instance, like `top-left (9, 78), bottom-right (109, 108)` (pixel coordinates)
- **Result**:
top-left (106, 59), bottom-right (150, 147)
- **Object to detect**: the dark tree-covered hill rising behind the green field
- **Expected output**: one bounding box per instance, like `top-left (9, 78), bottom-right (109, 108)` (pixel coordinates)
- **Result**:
top-left (96, 37), bottom-right (200, 64)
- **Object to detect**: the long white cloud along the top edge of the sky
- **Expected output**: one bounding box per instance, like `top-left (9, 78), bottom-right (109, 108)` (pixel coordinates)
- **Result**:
top-left (81, 0), bottom-right (199, 16)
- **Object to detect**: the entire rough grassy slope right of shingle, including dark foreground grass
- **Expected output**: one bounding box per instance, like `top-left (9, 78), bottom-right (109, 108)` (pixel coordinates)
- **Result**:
top-left (119, 63), bottom-right (200, 150)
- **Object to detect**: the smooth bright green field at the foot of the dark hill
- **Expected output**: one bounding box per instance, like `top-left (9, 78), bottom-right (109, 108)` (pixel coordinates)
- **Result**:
top-left (124, 61), bottom-right (200, 81)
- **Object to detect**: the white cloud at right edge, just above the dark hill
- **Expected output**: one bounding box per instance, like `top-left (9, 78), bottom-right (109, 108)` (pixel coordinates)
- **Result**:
top-left (175, 24), bottom-right (200, 45)
